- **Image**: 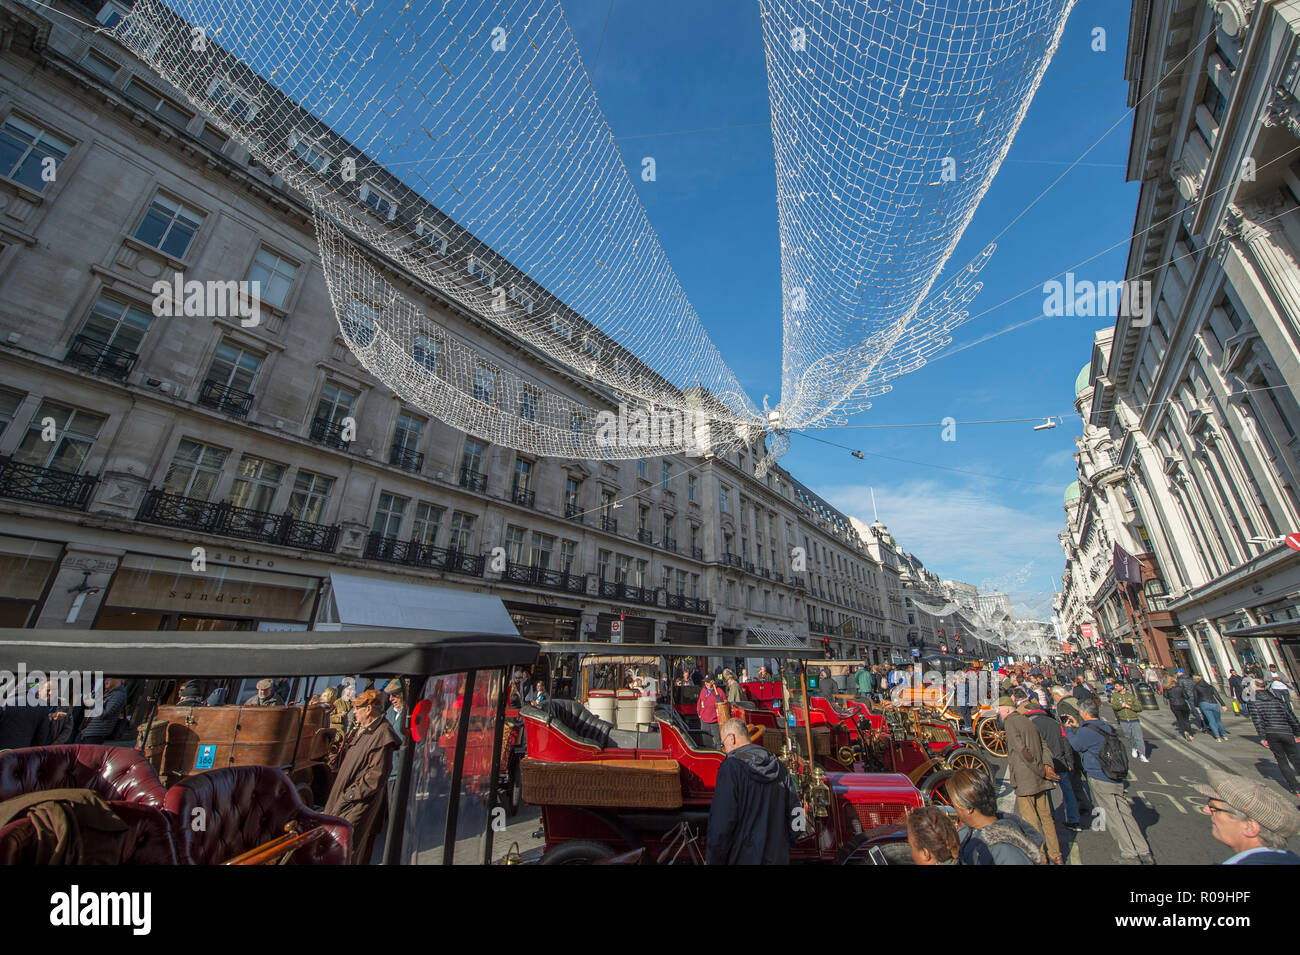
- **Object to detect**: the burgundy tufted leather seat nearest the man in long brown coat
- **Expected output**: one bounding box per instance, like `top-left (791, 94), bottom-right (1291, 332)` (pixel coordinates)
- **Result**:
top-left (165, 767), bottom-right (352, 865)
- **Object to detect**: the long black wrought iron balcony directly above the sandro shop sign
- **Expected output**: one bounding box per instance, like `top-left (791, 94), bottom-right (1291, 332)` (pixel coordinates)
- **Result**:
top-left (135, 487), bottom-right (338, 554)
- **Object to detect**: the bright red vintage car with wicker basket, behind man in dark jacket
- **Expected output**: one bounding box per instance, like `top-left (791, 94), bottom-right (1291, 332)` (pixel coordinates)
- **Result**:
top-left (521, 644), bottom-right (924, 864)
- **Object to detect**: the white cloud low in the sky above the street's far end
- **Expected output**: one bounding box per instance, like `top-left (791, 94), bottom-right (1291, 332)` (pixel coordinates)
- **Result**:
top-left (823, 481), bottom-right (1065, 620)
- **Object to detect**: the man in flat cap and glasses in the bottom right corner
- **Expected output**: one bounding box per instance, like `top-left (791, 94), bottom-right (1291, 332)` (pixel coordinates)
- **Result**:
top-left (1192, 769), bottom-right (1300, 865)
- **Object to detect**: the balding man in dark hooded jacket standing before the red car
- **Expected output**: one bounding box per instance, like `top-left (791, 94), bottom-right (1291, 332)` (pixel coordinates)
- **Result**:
top-left (707, 720), bottom-right (806, 865)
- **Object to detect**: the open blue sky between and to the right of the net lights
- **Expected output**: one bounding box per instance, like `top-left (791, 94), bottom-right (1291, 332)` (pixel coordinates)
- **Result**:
top-left (564, 0), bottom-right (1138, 617)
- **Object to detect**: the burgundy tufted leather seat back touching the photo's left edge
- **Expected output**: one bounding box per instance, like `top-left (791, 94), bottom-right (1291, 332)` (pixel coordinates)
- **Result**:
top-left (0, 746), bottom-right (166, 808)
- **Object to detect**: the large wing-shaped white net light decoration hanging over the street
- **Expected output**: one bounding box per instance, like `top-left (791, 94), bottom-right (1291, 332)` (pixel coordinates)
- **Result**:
top-left (113, 0), bottom-right (1071, 468)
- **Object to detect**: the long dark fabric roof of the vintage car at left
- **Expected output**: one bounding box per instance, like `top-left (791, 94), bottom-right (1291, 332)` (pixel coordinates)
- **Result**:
top-left (0, 628), bottom-right (538, 678)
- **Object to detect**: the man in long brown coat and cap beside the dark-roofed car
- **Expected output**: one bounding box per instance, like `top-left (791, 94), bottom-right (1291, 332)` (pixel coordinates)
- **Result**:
top-left (325, 690), bottom-right (402, 865)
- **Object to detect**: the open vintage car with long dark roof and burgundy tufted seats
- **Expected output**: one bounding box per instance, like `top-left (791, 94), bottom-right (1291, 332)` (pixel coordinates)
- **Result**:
top-left (0, 629), bottom-right (538, 865)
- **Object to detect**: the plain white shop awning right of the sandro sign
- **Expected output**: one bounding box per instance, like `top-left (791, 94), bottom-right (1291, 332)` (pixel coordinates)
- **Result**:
top-left (317, 572), bottom-right (519, 637)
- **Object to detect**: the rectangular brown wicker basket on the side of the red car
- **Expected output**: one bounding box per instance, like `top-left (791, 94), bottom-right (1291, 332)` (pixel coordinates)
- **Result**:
top-left (520, 759), bottom-right (681, 809)
